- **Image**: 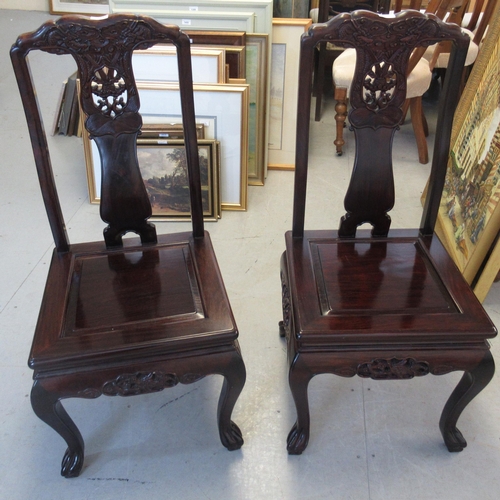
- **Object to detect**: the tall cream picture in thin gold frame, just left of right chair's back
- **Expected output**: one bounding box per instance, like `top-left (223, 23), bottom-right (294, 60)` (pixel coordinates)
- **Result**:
top-left (268, 18), bottom-right (312, 170)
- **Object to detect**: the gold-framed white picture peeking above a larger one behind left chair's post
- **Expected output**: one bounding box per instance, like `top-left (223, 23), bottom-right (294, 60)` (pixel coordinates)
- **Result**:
top-left (132, 45), bottom-right (226, 83)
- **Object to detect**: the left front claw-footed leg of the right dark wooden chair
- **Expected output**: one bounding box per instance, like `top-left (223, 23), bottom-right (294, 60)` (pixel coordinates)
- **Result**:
top-left (287, 362), bottom-right (313, 455)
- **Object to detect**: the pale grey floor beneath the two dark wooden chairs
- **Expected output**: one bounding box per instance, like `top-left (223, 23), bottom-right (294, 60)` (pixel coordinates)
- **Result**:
top-left (0, 10), bottom-right (500, 500)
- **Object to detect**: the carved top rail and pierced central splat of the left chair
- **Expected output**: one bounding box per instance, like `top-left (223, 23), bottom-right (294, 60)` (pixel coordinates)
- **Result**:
top-left (15, 16), bottom-right (205, 247)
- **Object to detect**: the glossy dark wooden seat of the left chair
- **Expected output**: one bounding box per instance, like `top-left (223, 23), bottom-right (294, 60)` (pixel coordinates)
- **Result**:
top-left (29, 233), bottom-right (238, 370)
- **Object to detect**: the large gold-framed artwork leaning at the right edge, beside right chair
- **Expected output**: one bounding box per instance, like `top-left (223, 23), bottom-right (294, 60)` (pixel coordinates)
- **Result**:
top-left (436, 0), bottom-right (500, 299)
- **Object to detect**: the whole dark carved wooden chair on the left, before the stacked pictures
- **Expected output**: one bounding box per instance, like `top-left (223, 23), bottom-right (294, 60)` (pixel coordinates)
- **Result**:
top-left (11, 15), bottom-right (245, 477)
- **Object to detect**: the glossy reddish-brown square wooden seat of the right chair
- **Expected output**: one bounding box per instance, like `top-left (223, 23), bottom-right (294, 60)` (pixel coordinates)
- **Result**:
top-left (286, 230), bottom-right (496, 346)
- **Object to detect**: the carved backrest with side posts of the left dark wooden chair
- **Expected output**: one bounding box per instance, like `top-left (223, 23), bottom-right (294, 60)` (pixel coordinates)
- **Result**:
top-left (11, 14), bottom-right (204, 252)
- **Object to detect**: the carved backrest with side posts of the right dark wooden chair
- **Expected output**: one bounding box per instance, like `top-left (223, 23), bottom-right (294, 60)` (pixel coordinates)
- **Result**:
top-left (293, 11), bottom-right (470, 238)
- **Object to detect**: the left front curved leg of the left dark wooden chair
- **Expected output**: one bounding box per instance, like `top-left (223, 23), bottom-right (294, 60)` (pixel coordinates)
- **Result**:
top-left (31, 381), bottom-right (84, 477)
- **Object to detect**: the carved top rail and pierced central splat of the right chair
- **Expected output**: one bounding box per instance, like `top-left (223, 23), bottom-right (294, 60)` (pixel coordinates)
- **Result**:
top-left (310, 11), bottom-right (465, 236)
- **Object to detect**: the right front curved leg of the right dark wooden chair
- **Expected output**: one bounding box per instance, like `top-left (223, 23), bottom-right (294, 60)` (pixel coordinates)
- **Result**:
top-left (439, 351), bottom-right (495, 451)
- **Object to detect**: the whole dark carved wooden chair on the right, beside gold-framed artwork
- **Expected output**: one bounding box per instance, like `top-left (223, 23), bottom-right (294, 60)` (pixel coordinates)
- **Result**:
top-left (280, 11), bottom-right (496, 454)
